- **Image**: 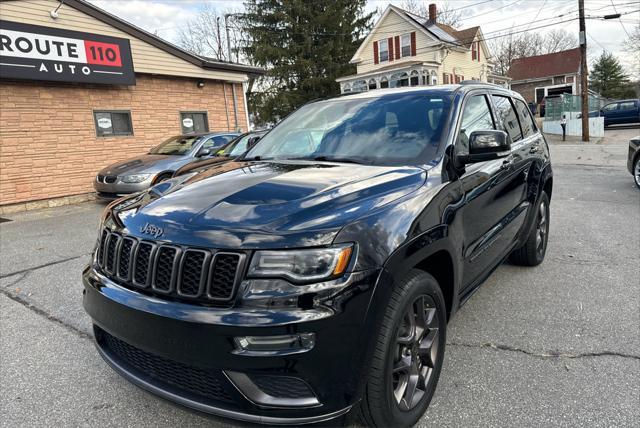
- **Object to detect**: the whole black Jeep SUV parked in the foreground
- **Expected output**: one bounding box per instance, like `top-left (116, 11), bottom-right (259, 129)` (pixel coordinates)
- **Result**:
top-left (83, 83), bottom-right (552, 426)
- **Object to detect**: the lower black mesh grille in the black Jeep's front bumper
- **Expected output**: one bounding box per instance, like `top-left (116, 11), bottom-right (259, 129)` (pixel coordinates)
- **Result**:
top-left (95, 327), bottom-right (233, 402)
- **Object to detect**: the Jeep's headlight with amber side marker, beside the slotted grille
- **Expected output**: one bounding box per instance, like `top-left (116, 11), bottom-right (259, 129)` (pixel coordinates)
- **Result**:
top-left (247, 244), bottom-right (353, 282)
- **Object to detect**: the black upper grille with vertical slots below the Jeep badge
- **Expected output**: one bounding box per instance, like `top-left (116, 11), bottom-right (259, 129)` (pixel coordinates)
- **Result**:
top-left (97, 229), bottom-right (245, 304)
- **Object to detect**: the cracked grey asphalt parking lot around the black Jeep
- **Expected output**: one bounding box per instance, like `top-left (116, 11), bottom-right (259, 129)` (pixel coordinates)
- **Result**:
top-left (0, 142), bottom-right (640, 427)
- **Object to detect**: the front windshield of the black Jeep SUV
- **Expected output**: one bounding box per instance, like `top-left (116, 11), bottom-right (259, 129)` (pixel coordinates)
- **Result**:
top-left (245, 93), bottom-right (451, 165)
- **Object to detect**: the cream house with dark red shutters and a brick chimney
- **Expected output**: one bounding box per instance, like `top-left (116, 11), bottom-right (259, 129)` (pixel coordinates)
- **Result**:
top-left (336, 4), bottom-right (510, 93)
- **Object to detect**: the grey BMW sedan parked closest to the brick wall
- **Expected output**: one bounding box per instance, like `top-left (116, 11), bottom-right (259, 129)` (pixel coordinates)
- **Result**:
top-left (93, 132), bottom-right (238, 199)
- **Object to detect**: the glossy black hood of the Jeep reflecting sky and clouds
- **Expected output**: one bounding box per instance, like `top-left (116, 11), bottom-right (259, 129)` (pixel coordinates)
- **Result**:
top-left (115, 161), bottom-right (426, 248)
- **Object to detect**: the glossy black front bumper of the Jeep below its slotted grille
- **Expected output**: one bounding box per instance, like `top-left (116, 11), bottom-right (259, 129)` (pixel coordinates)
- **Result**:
top-left (83, 268), bottom-right (379, 425)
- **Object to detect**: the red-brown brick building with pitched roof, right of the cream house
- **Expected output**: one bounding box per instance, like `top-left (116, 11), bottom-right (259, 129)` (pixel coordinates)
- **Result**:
top-left (507, 48), bottom-right (580, 108)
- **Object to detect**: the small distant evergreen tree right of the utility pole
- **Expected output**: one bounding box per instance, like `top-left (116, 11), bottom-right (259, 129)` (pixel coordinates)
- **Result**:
top-left (589, 51), bottom-right (633, 98)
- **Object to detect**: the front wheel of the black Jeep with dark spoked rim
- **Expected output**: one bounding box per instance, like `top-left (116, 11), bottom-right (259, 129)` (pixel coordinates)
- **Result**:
top-left (356, 269), bottom-right (447, 427)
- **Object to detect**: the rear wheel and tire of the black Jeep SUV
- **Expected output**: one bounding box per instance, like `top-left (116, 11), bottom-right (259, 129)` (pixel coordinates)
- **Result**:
top-left (509, 192), bottom-right (550, 266)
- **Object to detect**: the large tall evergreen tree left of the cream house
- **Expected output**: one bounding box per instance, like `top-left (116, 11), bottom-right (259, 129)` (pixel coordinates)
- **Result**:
top-left (242, 0), bottom-right (373, 124)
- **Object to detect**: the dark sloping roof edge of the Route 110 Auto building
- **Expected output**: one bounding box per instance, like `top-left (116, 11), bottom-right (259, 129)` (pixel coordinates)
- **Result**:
top-left (64, 0), bottom-right (265, 75)
